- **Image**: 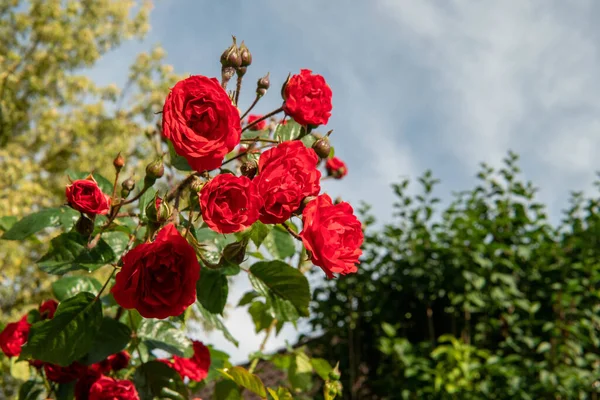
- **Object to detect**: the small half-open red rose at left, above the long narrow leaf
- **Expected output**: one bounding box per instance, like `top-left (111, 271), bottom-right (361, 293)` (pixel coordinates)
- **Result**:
top-left (65, 175), bottom-right (110, 215)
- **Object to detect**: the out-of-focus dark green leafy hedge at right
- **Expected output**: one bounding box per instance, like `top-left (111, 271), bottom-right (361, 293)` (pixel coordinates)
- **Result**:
top-left (312, 154), bottom-right (600, 399)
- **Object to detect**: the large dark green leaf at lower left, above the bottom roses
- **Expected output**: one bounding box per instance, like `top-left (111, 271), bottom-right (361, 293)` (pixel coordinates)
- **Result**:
top-left (21, 292), bottom-right (102, 367)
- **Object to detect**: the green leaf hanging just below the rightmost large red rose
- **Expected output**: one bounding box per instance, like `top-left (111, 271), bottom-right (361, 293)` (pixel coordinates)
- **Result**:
top-left (249, 260), bottom-right (310, 319)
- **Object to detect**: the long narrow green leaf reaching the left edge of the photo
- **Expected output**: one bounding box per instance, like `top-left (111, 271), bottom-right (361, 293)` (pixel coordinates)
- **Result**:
top-left (2, 207), bottom-right (79, 240)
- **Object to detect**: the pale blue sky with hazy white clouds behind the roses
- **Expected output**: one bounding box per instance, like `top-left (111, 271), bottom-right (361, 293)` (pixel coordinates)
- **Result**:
top-left (92, 0), bottom-right (600, 360)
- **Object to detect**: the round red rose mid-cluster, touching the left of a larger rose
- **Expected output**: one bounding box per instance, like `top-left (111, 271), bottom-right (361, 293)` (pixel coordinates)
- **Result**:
top-left (200, 174), bottom-right (262, 233)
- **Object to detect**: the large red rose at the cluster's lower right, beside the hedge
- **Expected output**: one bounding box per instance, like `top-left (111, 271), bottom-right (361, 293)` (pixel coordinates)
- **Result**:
top-left (300, 194), bottom-right (364, 278)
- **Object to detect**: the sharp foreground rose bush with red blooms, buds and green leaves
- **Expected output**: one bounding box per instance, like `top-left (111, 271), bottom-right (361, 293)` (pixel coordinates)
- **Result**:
top-left (0, 38), bottom-right (363, 400)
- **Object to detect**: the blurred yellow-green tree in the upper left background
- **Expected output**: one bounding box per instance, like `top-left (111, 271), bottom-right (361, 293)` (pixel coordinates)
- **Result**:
top-left (0, 0), bottom-right (177, 397)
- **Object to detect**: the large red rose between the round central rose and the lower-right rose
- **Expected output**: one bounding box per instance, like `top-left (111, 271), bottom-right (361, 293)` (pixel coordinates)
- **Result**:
top-left (254, 140), bottom-right (321, 224)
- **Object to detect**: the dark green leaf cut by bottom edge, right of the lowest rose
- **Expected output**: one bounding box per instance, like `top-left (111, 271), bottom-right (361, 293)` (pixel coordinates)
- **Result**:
top-left (133, 361), bottom-right (189, 400)
